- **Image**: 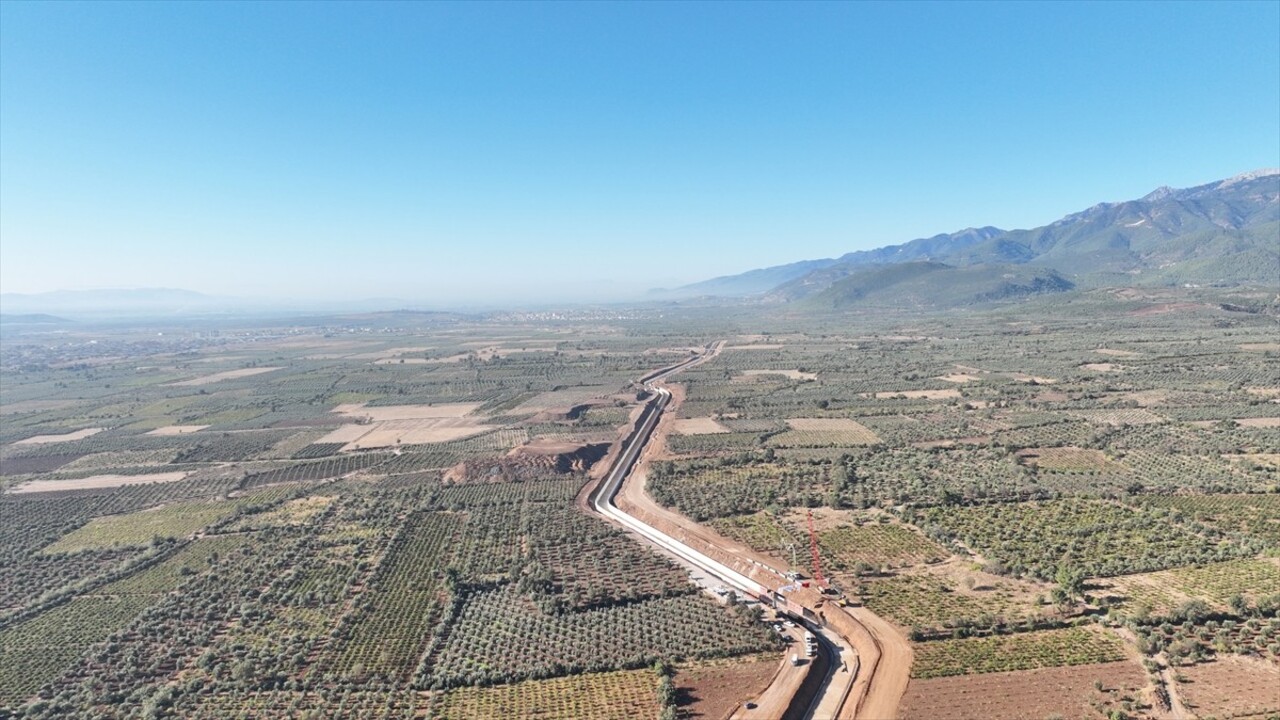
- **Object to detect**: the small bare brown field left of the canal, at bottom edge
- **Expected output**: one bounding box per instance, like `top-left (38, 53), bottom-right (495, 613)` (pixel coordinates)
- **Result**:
top-left (675, 653), bottom-right (778, 720)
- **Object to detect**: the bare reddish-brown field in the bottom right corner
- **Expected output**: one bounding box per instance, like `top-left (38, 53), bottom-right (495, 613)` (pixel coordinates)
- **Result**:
top-left (1178, 656), bottom-right (1280, 717)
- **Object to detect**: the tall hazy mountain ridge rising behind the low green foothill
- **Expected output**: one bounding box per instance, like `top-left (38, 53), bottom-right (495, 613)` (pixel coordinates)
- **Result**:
top-left (667, 169), bottom-right (1280, 302)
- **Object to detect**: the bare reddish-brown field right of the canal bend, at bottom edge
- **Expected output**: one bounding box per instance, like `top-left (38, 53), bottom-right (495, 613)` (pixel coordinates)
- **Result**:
top-left (900, 661), bottom-right (1147, 720)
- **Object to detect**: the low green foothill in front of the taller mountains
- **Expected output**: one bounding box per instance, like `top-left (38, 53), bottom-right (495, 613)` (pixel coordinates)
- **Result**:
top-left (797, 260), bottom-right (1075, 311)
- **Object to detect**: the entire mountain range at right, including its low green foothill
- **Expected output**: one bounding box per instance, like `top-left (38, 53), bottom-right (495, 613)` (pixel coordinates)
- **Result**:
top-left (652, 169), bottom-right (1280, 309)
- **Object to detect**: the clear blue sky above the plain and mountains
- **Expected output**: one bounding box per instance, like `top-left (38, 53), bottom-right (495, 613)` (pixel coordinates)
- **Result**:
top-left (0, 0), bottom-right (1280, 305)
